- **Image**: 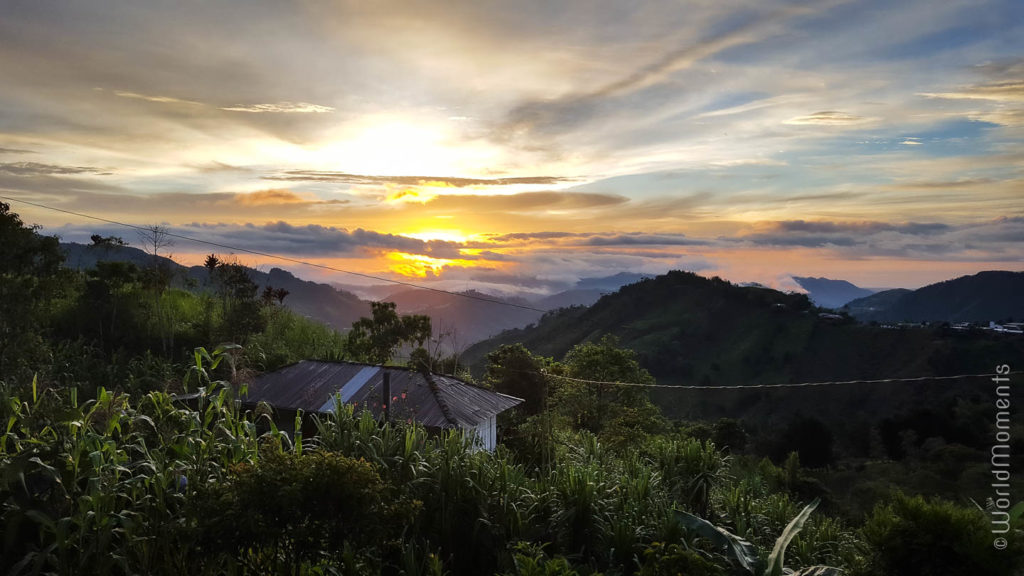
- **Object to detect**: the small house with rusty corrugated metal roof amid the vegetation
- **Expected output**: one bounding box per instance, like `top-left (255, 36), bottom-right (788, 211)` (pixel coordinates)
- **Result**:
top-left (242, 360), bottom-right (523, 450)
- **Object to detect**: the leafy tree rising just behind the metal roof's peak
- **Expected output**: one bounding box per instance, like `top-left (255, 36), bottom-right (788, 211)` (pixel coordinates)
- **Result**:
top-left (345, 302), bottom-right (431, 364)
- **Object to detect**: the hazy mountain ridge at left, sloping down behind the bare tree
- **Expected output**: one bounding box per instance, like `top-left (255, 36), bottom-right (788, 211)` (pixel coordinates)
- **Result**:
top-left (60, 243), bottom-right (370, 330)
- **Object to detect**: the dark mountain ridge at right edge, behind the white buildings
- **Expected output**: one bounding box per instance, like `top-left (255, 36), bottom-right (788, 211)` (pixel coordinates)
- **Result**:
top-left (847, 271), bottom-right (1024, 322)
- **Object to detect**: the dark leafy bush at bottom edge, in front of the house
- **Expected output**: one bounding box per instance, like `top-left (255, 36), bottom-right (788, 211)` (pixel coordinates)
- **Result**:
top-left (195, 451), bottom-right (413, 574)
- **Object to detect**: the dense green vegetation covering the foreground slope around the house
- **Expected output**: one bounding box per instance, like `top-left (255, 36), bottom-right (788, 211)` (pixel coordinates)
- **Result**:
top-left (0, 205), bottom-right (1024, 576)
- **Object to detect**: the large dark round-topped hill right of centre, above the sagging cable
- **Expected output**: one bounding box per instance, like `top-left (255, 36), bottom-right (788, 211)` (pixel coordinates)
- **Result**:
top-left (463, 272), bottom-right (1024, 393)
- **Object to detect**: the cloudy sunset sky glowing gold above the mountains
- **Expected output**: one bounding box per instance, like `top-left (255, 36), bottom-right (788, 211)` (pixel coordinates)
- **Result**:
top-left (0, 0), bottom-right (1024, 294)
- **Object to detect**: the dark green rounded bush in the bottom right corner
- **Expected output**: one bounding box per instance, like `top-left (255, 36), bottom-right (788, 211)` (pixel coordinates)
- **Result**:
top-left (863, 487), bottom-right (1024, 576)
